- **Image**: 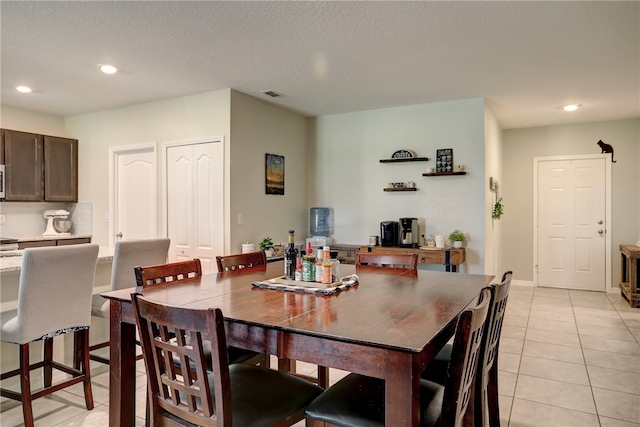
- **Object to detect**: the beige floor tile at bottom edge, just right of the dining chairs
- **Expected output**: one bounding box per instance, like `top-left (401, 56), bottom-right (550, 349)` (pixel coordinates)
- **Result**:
top-left (509, 398), bottom-right (600, 427)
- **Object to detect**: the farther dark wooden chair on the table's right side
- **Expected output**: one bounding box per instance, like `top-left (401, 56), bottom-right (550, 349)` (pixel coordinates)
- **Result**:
top-left (421, 271), bottom-right (513, 427)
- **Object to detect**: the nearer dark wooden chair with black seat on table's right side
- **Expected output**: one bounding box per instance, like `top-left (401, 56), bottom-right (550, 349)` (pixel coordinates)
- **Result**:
top-left (306, 288), bottom-right (490, 427)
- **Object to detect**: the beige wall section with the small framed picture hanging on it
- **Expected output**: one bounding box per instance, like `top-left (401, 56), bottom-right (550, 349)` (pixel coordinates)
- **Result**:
top-left (230, 91), bottom-right (309, 253)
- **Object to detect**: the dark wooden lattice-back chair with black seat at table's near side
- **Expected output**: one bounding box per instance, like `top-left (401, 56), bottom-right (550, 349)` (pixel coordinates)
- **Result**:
top-left (131, 294), bottom-right (323, 427)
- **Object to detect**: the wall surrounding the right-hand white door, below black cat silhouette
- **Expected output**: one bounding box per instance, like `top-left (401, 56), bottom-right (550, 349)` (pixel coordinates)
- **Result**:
top-left (501, 119), bottom-right (640, 290)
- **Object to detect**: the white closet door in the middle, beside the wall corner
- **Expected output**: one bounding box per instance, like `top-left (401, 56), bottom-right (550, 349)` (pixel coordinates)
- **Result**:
top-left (166, 142), bottom-right (224, 273)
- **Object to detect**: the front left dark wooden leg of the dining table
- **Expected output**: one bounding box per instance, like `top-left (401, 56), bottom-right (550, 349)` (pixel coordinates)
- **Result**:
top-left (109, 299), bottom-right (136, 427)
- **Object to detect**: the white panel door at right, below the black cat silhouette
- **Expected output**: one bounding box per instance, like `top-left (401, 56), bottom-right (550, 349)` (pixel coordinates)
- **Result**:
top-left (537, 159), bottom-right (606, 291)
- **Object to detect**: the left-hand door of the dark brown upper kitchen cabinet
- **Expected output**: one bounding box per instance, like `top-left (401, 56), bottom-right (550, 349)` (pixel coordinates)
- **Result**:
top-left (2, 130), bottom-right (44, 202)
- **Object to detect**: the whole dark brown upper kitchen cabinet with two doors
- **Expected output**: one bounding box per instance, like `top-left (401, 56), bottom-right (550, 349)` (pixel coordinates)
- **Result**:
top-left (0, 129), bottom-right (78, 202)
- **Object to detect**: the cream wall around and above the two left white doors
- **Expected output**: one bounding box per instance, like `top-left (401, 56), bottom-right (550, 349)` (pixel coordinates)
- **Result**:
top-left (66, 89), bottom-right (231, 246)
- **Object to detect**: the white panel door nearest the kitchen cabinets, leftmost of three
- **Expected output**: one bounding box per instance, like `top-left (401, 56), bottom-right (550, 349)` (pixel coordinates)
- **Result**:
top-left (109, 144), bottom-right (158, 246)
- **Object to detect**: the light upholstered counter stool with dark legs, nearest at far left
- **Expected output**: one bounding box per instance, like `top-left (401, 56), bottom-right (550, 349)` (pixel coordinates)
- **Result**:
top-left (0, 244), bottom-right (98, 427)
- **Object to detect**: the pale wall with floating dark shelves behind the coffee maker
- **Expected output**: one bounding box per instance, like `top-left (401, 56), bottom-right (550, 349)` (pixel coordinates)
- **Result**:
top-left (309, 98), bottom-right (485, 273)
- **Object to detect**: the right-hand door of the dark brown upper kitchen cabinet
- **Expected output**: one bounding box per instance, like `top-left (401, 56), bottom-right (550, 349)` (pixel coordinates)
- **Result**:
top-left (44, 136), bottom-right (78, 202)
